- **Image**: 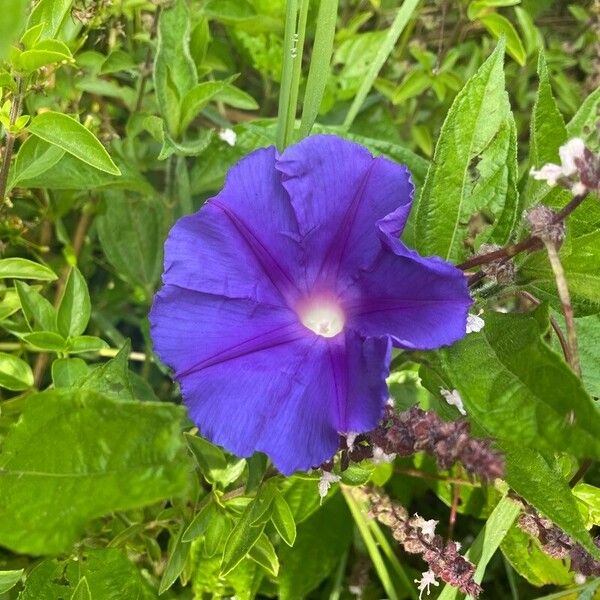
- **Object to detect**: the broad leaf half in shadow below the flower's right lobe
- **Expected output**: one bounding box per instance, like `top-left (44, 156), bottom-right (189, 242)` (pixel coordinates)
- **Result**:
top-left (432, 307), bottom-right (600, 458)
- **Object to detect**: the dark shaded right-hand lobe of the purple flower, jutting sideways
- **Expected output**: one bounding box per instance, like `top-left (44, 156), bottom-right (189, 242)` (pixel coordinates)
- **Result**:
top-left (344, 238), bottom-right (472, 350)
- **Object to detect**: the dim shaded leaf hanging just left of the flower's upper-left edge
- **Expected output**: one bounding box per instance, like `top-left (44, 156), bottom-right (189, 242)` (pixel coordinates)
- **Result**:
top-left (96, 191), bottom-right (165, 299)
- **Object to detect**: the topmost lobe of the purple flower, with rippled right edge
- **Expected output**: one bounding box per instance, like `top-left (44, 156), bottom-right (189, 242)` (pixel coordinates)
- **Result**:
top-left (277, 135), bottom-right (413, 285)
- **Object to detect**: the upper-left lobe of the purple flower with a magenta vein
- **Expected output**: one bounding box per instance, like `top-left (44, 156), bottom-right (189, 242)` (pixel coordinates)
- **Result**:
top-left (163, 148), bottom-right (303, 305)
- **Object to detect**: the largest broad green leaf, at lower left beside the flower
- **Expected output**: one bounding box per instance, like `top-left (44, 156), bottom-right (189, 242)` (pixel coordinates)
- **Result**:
top-left (0, 390), bottom-right (188, 552)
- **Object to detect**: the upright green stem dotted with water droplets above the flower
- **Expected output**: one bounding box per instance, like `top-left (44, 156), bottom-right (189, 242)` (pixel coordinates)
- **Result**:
top-left (277, 0), bottom-right (309, 151)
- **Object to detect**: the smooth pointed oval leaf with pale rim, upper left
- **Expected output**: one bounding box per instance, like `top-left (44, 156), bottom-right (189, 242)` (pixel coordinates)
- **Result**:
top-left (28, 111), bottom-right (121, 175)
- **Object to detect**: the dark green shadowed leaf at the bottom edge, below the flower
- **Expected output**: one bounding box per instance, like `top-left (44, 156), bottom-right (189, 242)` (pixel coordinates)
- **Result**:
top-left (278, 492), bottom-right (352, 600)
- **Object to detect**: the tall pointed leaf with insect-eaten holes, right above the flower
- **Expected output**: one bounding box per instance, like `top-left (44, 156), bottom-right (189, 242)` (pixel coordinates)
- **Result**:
top-left (413, 41), bottom-right (514, 260)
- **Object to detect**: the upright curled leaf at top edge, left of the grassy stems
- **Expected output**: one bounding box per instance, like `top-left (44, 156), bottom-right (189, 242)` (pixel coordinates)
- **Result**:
top-left (154, 0), bottom-right (198, 136)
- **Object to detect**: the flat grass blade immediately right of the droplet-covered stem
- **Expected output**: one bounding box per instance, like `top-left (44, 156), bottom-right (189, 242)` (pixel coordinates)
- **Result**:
top-left (299, 0), bottom-right (338, 138)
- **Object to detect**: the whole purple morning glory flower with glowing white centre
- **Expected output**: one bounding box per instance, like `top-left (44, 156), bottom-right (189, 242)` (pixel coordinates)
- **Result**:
top-left (150, 135), bottom-right (471, 474)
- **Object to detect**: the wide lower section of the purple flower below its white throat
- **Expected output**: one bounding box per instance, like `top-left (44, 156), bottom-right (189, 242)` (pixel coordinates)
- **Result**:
top-left (150, 286), bottom-right (389, 474)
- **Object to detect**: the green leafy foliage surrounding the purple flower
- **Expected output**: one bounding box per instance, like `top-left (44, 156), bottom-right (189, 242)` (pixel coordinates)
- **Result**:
top-left (0, 0), bottom-right (600, 600)
